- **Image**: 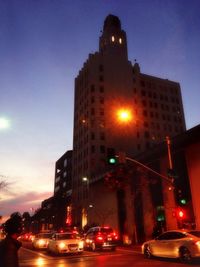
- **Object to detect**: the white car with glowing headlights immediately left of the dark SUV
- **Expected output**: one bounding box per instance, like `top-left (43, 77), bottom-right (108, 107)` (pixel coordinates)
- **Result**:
top-left (48, 232), bottom-right (83, 255)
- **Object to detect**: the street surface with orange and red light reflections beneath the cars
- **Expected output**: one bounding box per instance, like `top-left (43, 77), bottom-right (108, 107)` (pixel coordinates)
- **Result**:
top-left (19, 245), bottom-right (200, 267)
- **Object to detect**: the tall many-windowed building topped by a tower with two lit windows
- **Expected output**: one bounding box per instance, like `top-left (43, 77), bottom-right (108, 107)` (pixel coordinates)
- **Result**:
top-left (72, 15), bottom-right (185, 231)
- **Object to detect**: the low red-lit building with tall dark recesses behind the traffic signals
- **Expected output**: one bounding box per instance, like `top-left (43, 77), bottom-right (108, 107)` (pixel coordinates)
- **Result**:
top-left (86, 125), bottom-right (200, 243)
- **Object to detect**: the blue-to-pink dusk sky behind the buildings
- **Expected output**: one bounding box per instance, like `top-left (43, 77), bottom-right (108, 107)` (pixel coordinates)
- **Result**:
top-left (0, 0), bottom-right (200, 222)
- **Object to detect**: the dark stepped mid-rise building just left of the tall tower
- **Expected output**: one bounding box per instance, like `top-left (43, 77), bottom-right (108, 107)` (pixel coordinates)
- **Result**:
top-left (32, 150), bottom-right (73, 232)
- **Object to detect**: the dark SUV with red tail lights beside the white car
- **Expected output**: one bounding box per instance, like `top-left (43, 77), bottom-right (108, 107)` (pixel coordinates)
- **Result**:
top-left (84, 226), bottom-right (118, 251)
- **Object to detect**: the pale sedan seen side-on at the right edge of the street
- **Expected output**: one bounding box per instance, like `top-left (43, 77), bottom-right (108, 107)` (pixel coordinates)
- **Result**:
top-left (142, 230), bottom-right (200, 262)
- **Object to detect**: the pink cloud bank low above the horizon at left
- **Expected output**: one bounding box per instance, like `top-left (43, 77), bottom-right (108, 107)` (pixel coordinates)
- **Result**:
top-left (0, 191), bottom-right (52, 223)
